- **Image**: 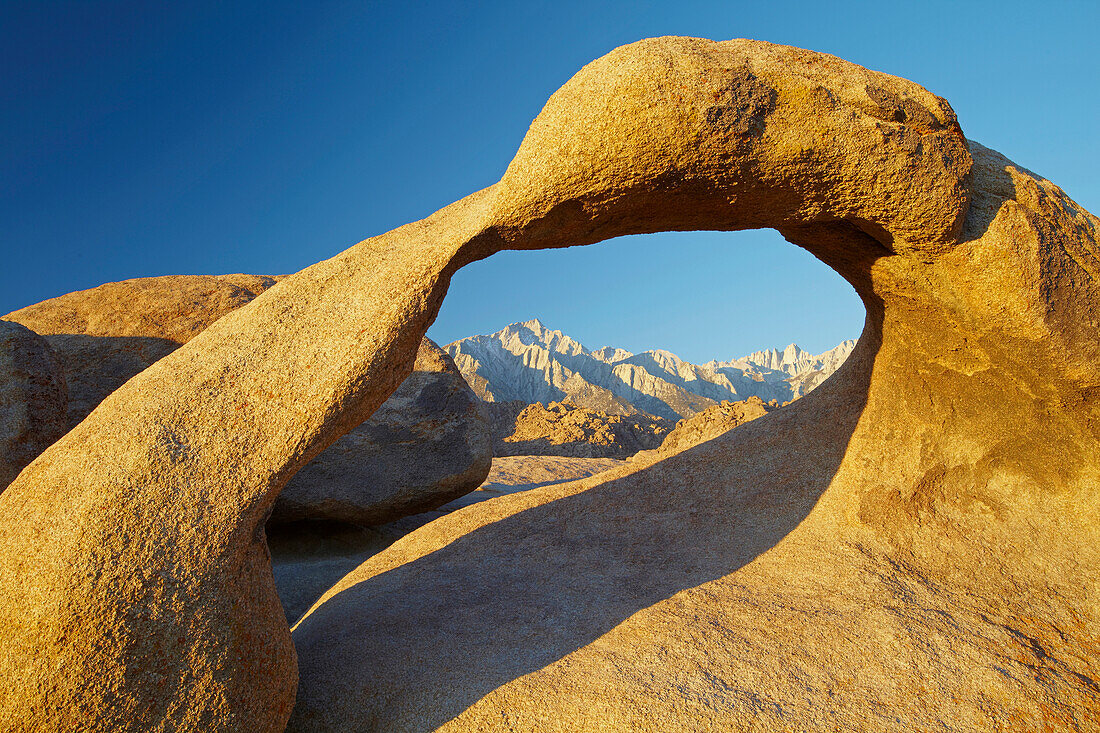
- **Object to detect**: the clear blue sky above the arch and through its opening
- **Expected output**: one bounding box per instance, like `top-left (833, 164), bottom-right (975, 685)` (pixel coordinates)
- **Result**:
top-left (0, 0), bottom-right (1100, 361)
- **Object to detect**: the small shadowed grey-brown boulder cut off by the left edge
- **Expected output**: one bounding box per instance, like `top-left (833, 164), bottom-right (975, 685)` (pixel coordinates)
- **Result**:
top-left (0, 320), bottom-right (67, 491)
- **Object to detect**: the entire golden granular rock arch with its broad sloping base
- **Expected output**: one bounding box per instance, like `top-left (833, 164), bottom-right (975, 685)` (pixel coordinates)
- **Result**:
top-left (0, 37), bottom-right (1100, 731)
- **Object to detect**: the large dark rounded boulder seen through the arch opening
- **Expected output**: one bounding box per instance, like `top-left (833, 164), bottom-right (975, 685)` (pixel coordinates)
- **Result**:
top-left (271, 339), bottom-right (493, 525)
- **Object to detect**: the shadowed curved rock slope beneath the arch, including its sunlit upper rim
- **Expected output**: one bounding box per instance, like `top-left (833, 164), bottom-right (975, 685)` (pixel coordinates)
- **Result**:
top-left (290, 328), bottom-right (878, 730)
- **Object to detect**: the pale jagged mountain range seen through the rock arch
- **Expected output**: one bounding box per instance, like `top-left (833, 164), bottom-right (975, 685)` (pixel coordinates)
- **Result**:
top-left (446, 319), bottom-right (856, 419)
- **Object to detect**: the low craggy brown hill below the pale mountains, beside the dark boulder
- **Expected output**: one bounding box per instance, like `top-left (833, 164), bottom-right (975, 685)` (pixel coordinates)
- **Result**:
top-left (482, 402), bottom-right (672, 459)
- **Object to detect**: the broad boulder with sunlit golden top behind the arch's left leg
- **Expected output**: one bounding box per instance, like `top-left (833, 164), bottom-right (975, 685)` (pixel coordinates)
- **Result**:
top-left (3, 275), bottom-right (275, 428)
